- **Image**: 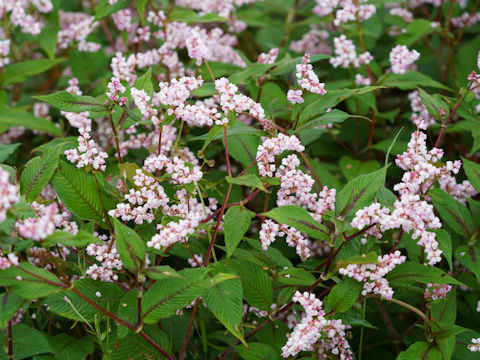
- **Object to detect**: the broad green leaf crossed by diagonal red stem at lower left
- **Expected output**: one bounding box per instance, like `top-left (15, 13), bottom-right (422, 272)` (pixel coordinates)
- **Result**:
top-left (45, 278), bottom-right (125, 322)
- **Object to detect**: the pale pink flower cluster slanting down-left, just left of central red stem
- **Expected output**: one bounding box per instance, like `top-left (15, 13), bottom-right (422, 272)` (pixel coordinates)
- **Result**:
top-left (147, 189), bottom-right (217, 250)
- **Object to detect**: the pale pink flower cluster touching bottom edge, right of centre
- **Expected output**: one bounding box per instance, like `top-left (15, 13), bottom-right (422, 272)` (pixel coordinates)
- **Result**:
top-left (282, 291), bottom-right (353, 360)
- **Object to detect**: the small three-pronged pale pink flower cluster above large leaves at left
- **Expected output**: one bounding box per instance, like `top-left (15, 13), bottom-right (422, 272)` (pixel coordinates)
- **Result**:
top-left (65, 127), bottom-right (108, 171)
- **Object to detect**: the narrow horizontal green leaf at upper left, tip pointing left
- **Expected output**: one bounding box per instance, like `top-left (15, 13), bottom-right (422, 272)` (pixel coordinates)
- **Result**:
top-left (33, 90), bottom-right (106, 112)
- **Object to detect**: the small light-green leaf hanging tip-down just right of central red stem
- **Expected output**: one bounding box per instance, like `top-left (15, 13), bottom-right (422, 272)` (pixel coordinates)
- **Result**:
top-left (223, 205), bottom-right (255, 258)
